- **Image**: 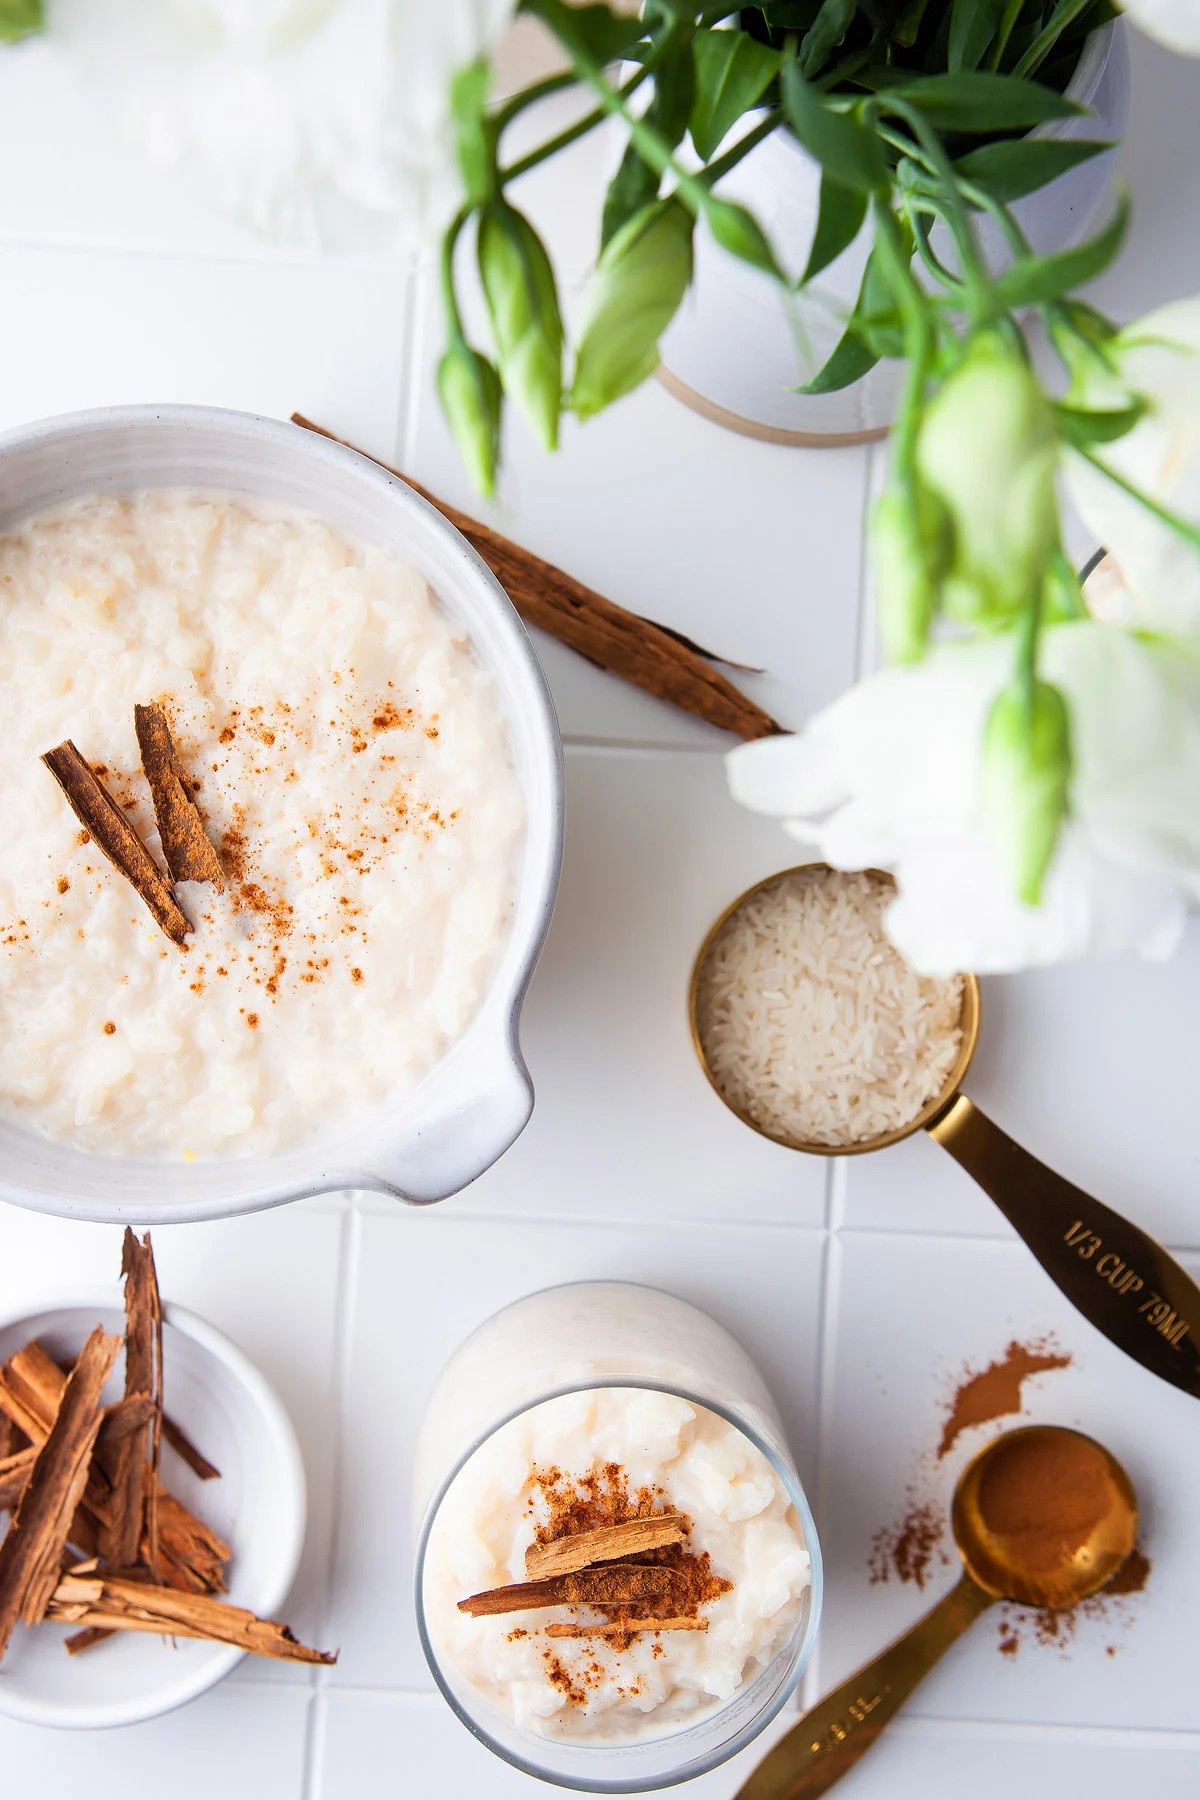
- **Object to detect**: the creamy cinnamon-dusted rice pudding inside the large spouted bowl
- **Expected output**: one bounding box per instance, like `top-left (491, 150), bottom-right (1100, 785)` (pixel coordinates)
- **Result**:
top-left (0, 488), bottom-right (524, 1163)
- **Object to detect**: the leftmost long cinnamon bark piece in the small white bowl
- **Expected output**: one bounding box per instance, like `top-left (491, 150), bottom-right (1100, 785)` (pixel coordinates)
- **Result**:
top-left (0, 1325), bottom-right (121, 1658)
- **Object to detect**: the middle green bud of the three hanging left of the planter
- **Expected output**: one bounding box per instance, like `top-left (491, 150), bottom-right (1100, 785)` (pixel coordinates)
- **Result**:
top-left (479, 205), bottom-right (563, 450)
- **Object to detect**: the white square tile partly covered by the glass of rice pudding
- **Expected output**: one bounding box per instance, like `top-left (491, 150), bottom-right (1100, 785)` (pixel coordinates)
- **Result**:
top-left (329, 1206), bottom-right (824, 1688)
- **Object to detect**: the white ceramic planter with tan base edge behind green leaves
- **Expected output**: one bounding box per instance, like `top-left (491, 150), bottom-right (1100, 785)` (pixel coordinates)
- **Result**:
top-left (660, 22), bottom-right (1130, 443)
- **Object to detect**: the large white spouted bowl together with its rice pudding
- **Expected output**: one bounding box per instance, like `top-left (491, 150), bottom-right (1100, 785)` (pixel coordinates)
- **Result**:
top-left (0, 409), bottom-right (561, 1219)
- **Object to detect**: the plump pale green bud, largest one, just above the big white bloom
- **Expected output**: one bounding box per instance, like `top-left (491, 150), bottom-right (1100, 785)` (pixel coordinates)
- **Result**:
top-left (916, 331), bottom-right (1058, 621)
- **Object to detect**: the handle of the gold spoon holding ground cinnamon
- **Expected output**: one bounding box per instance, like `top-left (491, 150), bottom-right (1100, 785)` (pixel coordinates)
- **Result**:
top-left (736, 1573), bottom-right (993, 1800)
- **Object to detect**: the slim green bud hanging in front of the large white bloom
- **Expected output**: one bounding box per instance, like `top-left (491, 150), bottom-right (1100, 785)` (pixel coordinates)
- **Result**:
top-left (982, 680), bottom-right (1070, 905)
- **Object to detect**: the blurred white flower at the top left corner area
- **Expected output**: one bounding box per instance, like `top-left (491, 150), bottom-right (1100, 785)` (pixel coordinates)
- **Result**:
top-left (39, 0), bottom-right (515, 248)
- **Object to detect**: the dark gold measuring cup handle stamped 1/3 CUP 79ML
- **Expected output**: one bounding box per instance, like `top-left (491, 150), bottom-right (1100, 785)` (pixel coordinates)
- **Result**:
top-left (925, 1094), bottom-right (1200, 1399)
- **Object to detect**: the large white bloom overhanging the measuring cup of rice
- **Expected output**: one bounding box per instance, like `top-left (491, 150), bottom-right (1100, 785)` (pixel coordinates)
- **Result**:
top-left (727, 621), bottom-right (1200, 974)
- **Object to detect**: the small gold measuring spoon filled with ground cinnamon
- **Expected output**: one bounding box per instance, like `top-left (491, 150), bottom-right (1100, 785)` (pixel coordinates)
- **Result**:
top-left (736, 1426), bottom-right (1137, 1800)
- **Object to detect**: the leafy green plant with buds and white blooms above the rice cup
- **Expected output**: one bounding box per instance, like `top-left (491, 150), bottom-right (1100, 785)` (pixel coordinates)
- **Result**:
top-left (429, 0), bottom-right (1200, 972)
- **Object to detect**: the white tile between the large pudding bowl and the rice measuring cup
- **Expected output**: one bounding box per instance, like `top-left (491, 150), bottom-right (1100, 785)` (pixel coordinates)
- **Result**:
top-left (448, 749), bottom-right (829, 1226)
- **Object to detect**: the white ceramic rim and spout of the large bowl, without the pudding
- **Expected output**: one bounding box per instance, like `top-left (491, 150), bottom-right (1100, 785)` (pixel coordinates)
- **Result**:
top-left (0, 407), bottom-right (563, 1224)
